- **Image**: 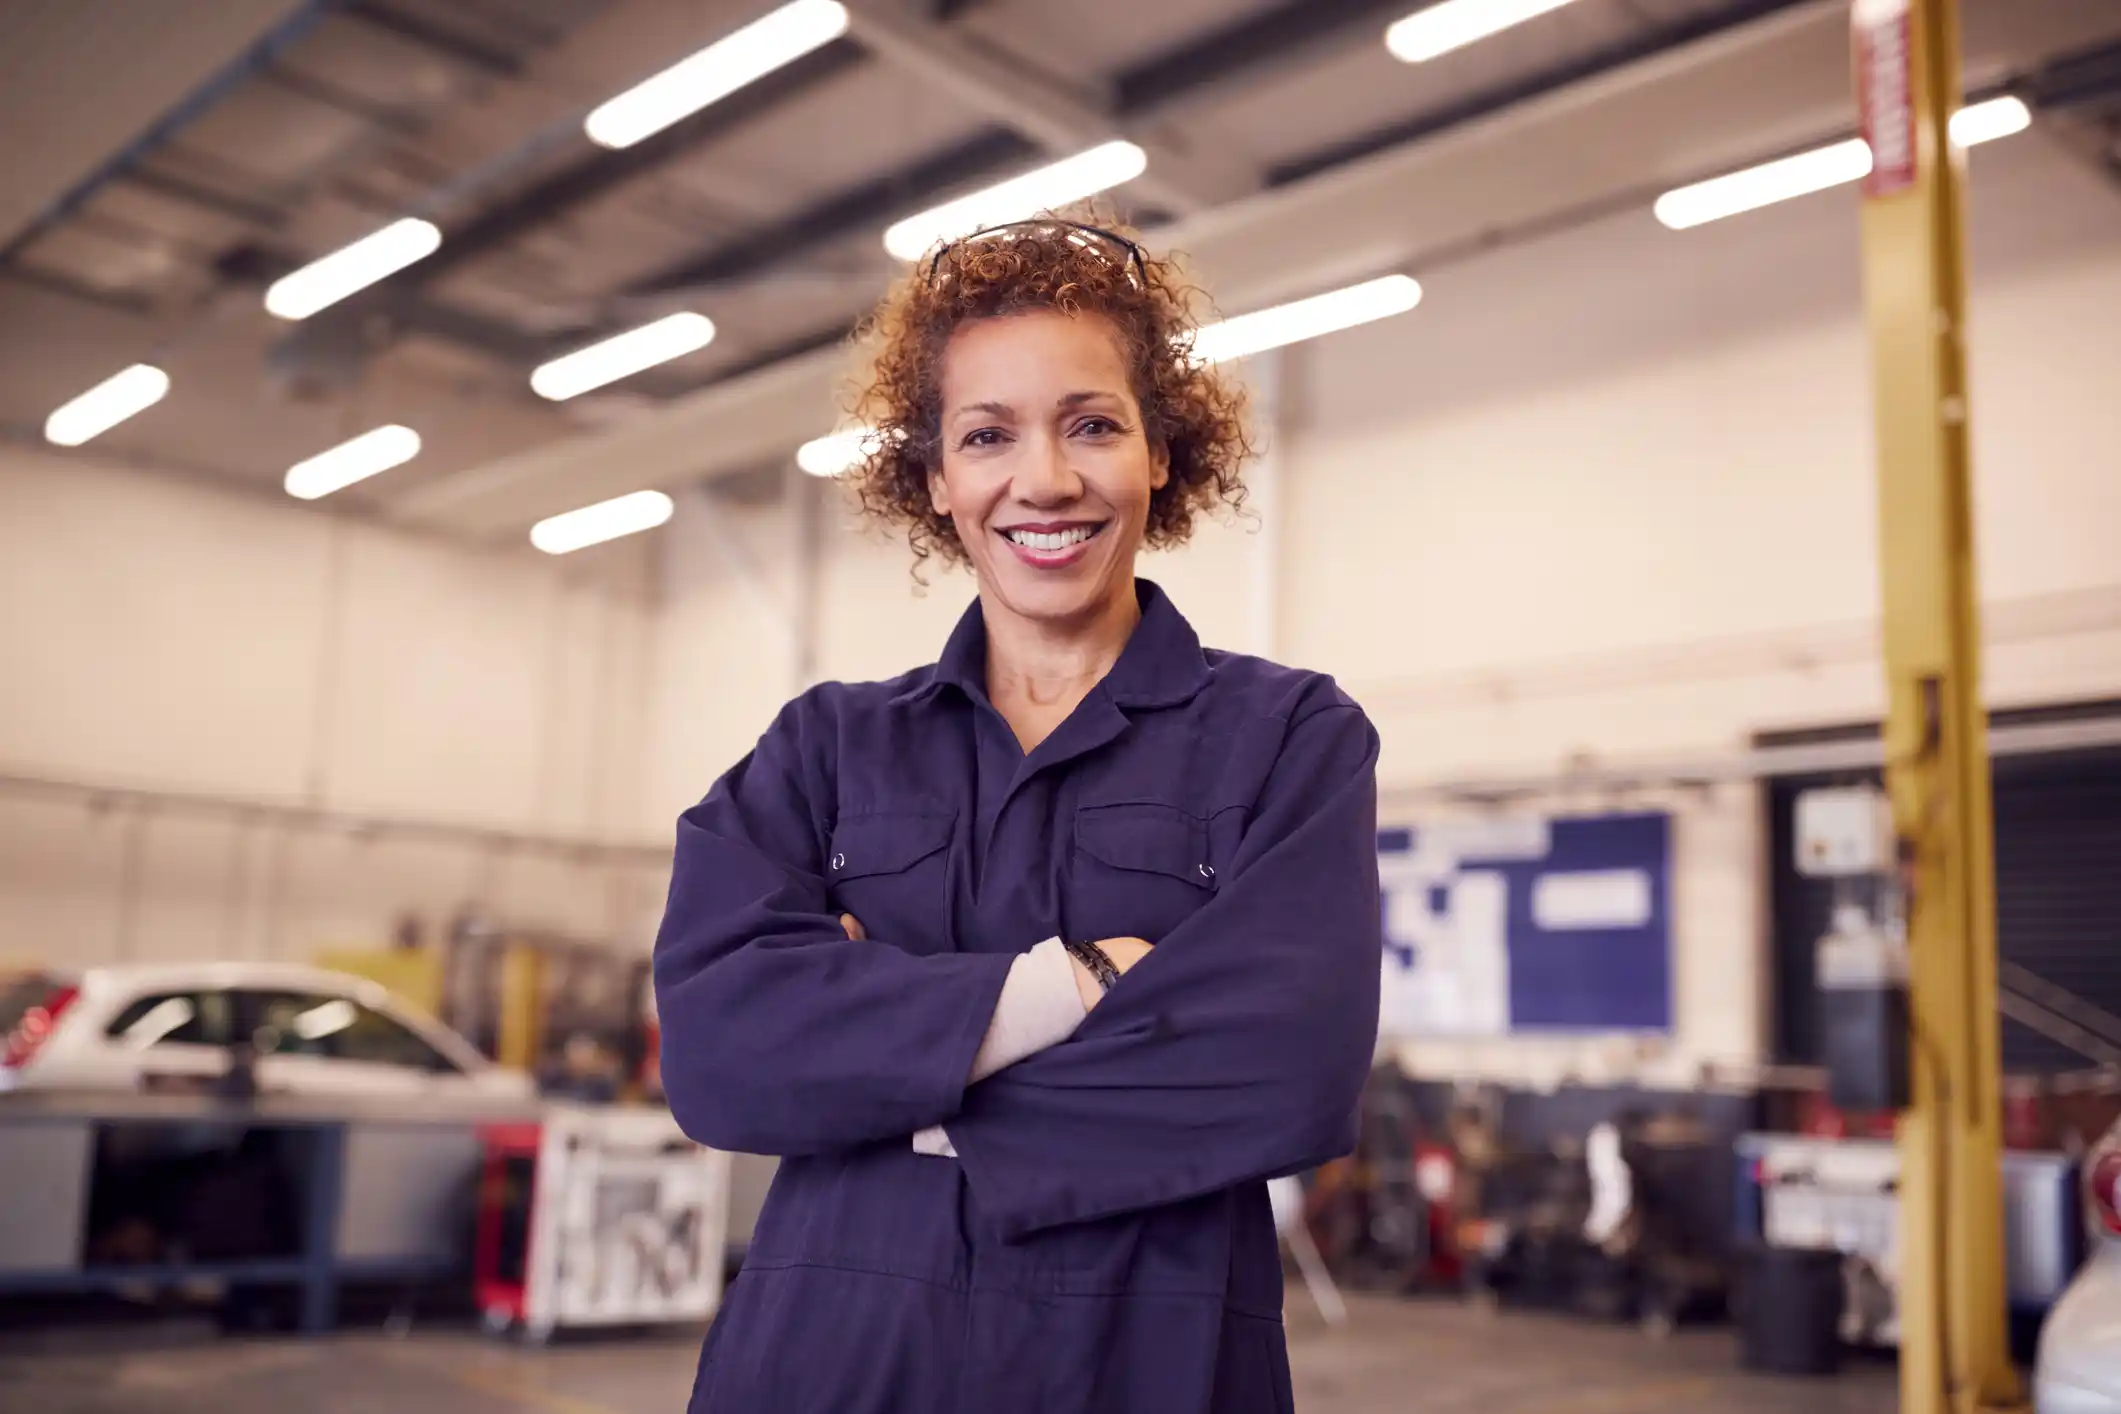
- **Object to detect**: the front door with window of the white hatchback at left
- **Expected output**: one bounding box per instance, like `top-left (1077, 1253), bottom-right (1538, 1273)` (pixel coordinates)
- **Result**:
top-left (250, 990), bottom-right (460, 1098)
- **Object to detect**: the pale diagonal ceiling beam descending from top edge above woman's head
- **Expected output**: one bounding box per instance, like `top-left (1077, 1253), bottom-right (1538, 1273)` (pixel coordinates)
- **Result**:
top-left (848, 0), bottom-right (1260, 212)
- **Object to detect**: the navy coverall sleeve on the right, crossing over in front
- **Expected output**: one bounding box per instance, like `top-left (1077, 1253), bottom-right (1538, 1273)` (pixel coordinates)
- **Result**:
top-left (946, 697), bottom-right (1383, 1238)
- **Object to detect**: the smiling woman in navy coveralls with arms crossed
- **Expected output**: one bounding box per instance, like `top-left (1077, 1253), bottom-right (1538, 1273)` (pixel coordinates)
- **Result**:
top-left (655, 218), bottom-right (1379, 1414)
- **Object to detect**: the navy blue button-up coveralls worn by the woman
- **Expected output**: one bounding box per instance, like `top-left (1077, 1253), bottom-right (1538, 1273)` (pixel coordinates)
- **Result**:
top-left (655, 583), bottom-right (1381, 1414)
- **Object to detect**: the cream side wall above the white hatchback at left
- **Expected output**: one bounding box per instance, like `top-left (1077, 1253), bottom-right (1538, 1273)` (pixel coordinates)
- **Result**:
top-left (0, 449), bottom-right (668, 979)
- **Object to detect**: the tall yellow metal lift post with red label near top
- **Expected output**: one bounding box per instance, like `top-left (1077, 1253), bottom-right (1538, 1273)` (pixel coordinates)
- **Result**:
top-left (1852, 0), bottom-right (2021, 1414)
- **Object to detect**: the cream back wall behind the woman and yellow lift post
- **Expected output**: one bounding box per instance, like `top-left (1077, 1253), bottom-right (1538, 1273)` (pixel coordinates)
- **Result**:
top-left (651, 134), bottom-right (2121, 1081)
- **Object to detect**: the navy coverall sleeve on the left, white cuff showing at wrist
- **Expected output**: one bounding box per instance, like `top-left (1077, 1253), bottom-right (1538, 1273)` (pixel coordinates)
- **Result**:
top-left (655, 700), bottom-right (1014, 1155)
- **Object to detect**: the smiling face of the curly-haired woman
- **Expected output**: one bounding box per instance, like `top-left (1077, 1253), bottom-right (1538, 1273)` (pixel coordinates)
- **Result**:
top-left (929, 310), bottom-right (1171, 628)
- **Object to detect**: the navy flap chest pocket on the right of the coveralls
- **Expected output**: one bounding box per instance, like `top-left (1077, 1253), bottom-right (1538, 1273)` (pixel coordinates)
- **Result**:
top-left (1067, 803), bottom-right (1215, 943)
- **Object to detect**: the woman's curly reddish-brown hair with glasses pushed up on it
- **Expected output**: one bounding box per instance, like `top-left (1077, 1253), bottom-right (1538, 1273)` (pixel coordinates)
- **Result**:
top-left (846, 214), bottom-right (1251, 577)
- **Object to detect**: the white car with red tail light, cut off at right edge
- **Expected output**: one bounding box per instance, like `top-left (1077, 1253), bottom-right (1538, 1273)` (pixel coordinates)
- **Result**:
top-left (2032, 1126), bottom-right (2121, 1414)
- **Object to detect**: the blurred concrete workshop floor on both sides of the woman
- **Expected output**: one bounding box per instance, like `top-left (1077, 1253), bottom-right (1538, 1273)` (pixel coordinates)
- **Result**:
top-left (0, 1295), bottom-right (1894, 1414)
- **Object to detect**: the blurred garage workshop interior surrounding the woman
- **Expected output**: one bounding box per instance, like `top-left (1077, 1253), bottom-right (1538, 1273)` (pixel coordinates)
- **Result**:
top-left (0, 0), bottom-right (2121, 1414)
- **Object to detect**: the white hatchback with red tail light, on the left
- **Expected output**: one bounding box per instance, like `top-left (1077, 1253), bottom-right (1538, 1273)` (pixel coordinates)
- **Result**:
top-left (0, 962), bottom-right (537, 1100)
